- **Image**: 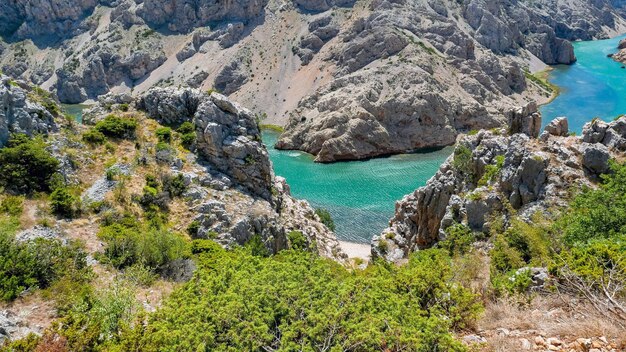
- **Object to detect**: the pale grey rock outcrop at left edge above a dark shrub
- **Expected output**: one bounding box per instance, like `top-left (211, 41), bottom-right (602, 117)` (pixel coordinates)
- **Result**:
top-left (0, 74), bottom-right (58, 147)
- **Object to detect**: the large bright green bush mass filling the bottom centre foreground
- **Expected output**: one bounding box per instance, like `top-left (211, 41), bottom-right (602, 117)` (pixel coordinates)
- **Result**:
top-left (109, 248), bottom-right (480, 351)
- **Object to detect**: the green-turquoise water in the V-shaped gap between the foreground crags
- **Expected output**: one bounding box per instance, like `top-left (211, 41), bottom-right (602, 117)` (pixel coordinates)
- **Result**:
top-left (263, 131), bottom-right (452, 243)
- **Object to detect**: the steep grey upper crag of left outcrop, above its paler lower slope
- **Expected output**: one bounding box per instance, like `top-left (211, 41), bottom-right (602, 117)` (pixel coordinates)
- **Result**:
top-left (137, 88), bottom-right (273, 200)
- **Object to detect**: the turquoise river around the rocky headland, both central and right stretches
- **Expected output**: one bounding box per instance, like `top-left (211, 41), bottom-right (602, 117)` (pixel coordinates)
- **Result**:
top-left (263, 36), bottom-right (626, 242)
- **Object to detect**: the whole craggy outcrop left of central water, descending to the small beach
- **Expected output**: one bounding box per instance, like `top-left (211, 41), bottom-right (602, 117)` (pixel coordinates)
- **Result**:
top-left (135, 88), bottom-right (345, 260)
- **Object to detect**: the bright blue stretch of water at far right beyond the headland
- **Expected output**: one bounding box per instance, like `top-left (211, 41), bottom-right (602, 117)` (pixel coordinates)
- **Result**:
top-left (540, 35), bottom-right (626, 134)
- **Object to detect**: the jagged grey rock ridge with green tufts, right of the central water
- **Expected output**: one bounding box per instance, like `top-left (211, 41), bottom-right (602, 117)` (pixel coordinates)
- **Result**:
top-left (372, 107), bottom-right (626, 261)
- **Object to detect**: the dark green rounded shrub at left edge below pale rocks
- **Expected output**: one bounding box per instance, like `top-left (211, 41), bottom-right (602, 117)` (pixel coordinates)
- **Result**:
top-left (0, 134), bottom-right (59, 194)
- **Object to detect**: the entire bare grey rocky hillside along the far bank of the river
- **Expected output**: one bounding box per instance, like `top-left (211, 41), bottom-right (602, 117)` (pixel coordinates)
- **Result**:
top-left (0, 0), bottom-right (624, 161)
